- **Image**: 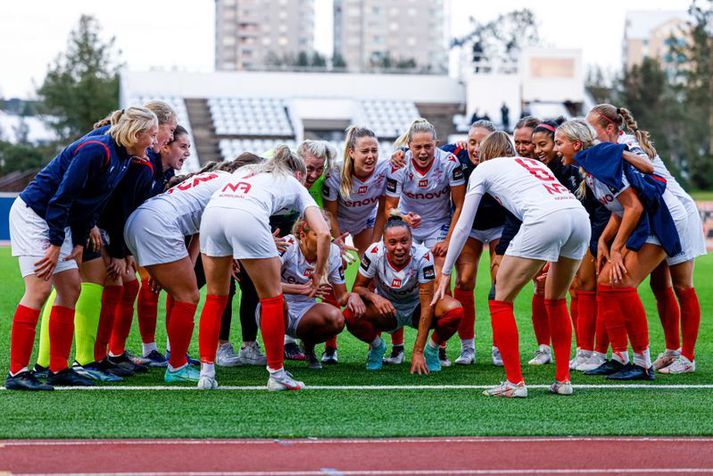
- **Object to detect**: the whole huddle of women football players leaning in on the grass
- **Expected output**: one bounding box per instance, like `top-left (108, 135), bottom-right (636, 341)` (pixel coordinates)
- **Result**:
top-left (5, 101), bottom-right (706, 397)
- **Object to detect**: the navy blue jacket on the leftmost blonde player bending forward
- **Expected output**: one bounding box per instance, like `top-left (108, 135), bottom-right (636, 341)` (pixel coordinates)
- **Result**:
top-left (20, 135), bottom-right (129, 246)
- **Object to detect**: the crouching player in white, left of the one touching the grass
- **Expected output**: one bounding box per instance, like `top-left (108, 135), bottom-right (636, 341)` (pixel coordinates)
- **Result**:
top-left (268, 216), bottom-right (366, 369)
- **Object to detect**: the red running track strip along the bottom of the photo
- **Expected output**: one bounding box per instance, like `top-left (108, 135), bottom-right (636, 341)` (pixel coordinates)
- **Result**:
top-left (0, 437), bottom-right (713, 476)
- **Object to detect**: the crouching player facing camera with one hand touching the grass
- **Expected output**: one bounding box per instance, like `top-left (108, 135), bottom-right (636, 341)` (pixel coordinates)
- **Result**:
top-left (344, 217), bottom-right (463, 374)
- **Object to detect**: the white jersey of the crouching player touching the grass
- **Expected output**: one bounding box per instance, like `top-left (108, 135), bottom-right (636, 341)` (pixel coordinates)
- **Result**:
top-left (359, 242), bottom-right (436, 307)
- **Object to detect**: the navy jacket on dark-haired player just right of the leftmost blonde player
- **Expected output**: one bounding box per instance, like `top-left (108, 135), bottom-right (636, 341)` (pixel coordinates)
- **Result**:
top-left (98, 151), bottom-right (175, 258)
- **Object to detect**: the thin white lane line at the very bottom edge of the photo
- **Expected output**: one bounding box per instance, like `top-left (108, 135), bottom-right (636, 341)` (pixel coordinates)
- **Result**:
top-left (13, 468), bottom-right (713, 476)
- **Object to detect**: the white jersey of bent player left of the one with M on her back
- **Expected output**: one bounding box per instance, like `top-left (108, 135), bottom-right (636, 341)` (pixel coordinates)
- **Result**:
top-left (138, 170), bottom-right (231, 236)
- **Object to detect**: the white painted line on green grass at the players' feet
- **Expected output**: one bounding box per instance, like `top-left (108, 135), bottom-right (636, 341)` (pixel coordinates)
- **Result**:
top-left (0, 383), bottom-right (713, 391)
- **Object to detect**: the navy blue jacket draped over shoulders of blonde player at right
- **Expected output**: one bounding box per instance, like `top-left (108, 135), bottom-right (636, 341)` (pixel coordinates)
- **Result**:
top-left (574, 143), bottom-right (681, 256)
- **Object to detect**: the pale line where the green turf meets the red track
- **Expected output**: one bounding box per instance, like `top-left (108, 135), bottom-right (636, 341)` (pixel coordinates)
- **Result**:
top-left (5, 436), bottom-right (713, 448)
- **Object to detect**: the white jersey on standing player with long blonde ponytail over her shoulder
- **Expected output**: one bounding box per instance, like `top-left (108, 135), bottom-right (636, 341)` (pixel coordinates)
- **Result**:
top-left (322, 160), bottom-right (391, 227)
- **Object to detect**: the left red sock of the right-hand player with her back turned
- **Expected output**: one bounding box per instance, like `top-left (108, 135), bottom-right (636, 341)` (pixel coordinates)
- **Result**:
top-left (488, 301), bottom-right (523, 384)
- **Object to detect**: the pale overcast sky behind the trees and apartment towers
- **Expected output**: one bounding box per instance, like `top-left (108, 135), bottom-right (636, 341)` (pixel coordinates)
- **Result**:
top-left (0, 0), bottom-right (690, 98)
